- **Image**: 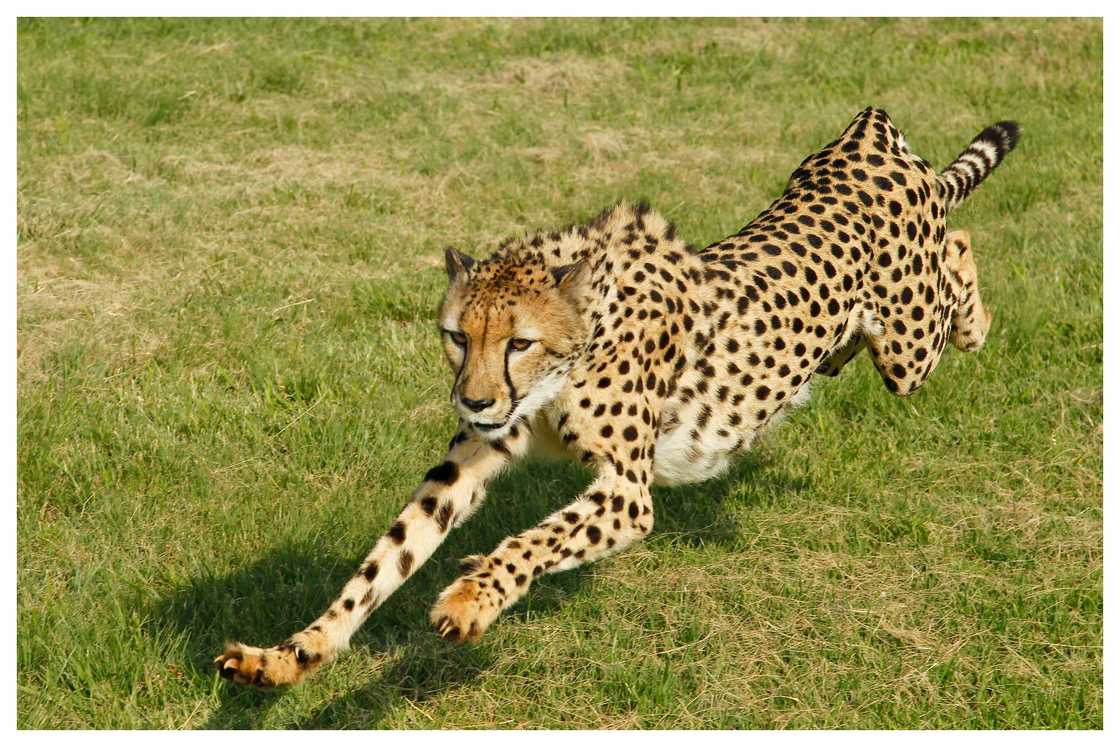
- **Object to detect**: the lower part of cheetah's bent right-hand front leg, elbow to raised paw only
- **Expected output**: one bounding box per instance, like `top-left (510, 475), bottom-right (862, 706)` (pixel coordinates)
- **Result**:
top-left (431, 468), bottom-right (653, 642)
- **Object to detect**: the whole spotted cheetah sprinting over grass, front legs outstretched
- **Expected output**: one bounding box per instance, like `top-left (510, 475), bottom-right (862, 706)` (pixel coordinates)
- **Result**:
top-left (215, 108), bottom-right (1019, 687)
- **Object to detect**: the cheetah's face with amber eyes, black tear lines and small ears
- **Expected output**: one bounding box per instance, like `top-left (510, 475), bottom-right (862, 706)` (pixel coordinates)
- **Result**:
top-left (439, 249), bottom-right (585, 439)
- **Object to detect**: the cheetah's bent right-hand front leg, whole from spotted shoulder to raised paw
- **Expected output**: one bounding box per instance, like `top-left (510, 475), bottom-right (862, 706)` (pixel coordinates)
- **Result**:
top-left (431, 344), bottom-right (678, 642)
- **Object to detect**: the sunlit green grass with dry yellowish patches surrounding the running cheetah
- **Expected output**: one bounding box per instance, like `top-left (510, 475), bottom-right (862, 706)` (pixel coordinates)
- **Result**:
top-left (17, 20), bottom-right (1103, 728)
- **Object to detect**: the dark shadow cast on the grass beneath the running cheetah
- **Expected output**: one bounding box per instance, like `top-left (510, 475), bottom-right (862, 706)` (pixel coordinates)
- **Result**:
top-left (148, 452), bottom-right (805, 729)
